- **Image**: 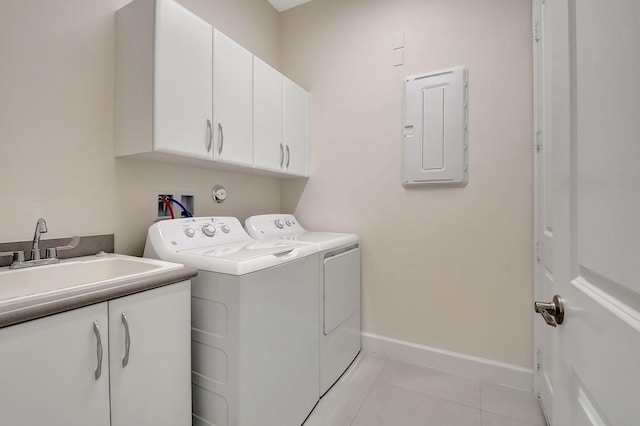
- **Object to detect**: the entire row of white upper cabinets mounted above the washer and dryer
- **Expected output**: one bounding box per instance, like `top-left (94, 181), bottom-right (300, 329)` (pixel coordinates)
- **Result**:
top-left (115, 0), bottom-right (307, 176)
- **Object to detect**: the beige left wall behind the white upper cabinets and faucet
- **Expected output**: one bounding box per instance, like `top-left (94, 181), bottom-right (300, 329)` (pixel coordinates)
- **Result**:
top-left (0, 0), bottom-right (280, 254)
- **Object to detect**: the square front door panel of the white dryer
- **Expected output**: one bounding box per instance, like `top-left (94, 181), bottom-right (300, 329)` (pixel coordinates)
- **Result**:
top-left (323, 245), bottom-right (360, 335)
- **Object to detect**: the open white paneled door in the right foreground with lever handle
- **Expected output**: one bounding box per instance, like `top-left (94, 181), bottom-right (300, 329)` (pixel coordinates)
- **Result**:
top-left (547, 0), bottom-right (640, 426)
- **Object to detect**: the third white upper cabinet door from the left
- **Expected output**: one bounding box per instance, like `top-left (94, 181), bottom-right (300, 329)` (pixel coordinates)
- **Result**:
top-left (253, 56), bottom-right (285, 172)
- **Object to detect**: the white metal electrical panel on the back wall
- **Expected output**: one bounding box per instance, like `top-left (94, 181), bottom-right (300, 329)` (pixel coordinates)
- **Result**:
top-left (402, 67), bottom-right (469, 186)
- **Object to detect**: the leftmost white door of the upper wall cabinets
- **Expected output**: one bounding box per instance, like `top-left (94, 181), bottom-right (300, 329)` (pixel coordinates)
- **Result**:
top-left (153, 0), bottom-right (213, 158)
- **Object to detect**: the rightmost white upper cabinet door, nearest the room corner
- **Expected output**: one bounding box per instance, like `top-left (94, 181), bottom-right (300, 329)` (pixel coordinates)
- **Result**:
top-left (284, 78), bottom-right (307, 176)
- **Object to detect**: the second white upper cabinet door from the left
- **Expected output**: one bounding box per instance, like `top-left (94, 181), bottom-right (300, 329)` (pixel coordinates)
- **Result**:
top-left (213, 29), bottom-right (253, 167)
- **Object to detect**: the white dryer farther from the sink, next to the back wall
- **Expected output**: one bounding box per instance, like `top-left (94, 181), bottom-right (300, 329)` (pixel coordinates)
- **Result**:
top-left (245, 214), bottom-right (361, 396)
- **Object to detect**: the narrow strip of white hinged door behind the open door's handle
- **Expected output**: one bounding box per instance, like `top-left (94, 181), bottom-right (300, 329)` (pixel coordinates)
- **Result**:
top-left (533, 0), bottom-right (558, 419)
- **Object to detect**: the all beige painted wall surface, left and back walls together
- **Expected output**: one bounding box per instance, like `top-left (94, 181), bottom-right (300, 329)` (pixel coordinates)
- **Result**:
top-left (0, 0), bottom-right (532, 367)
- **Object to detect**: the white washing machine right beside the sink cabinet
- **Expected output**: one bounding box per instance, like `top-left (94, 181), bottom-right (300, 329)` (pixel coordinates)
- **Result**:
top-left (144, 217), bottom-right (320, 426)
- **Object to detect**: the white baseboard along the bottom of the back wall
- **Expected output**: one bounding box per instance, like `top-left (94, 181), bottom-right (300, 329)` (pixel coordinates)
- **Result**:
top-left (362, 333), bottom-right (533, 390)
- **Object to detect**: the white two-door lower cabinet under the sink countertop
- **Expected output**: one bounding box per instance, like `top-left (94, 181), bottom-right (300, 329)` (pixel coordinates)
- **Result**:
top-left (0, 281), bottom-right (191, 426)
